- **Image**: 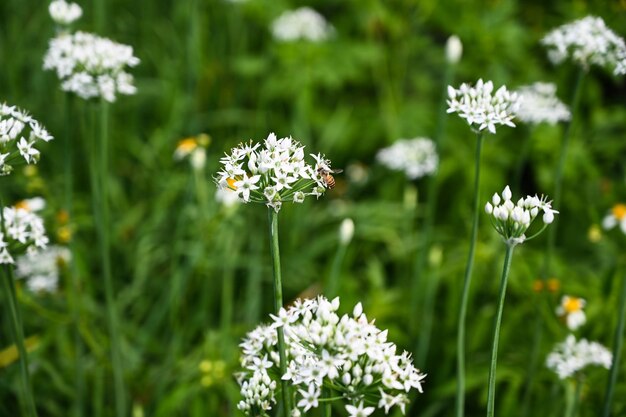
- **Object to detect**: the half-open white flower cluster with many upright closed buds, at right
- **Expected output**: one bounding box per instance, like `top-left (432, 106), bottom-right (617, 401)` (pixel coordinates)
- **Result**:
top-left (485, 185), bottom-right (558, 245)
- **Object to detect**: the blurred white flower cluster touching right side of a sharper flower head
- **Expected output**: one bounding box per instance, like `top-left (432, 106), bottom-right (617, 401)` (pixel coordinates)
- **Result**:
top-left (515, 82), bottom-right (572, 125)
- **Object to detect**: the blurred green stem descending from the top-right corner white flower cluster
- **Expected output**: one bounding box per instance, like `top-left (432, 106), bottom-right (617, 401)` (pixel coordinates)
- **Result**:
top-left (542, 68), bottom-right (585, 280)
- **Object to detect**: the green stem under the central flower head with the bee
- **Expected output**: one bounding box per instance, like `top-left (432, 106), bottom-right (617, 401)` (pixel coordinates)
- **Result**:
top-left (268, 207), bottom-right (291, 417)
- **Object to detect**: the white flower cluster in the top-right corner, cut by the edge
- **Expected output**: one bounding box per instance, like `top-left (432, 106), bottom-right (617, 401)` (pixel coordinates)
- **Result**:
top-left (541, 16), bottom-right (626, 75)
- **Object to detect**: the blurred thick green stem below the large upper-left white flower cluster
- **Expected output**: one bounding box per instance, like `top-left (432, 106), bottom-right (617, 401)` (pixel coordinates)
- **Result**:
top-left (95, 99), bottom-right (126, 417)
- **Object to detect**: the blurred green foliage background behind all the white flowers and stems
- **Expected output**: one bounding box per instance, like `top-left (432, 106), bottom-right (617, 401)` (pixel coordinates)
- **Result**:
top-left (0, 0), bottom-right (626, 417)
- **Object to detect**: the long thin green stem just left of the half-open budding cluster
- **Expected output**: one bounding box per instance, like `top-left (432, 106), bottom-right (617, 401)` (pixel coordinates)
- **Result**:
top-left (456, 132), bottom-right (483, 417)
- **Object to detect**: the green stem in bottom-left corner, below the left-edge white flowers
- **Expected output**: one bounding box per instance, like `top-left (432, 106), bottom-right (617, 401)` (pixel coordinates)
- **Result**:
top-left (2, 264), bottom-right (37, 417)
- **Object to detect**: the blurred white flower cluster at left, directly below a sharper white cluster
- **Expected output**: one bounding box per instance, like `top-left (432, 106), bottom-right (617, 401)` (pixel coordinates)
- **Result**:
top-left (15, 246), bottom-right (71, 293)
